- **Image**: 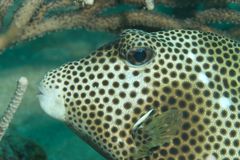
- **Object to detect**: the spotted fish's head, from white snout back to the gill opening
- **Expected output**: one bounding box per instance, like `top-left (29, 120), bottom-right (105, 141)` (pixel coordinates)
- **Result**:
top-left (38, 30), bottom-right (161, 157)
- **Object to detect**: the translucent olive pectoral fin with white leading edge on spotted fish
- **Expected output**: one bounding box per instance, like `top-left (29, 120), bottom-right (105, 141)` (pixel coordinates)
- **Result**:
top-left (132, 109), bottom-right (182, 159)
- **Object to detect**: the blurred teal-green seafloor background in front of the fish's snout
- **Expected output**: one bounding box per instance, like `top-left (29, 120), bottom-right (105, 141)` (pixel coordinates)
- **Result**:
top-left (0, 30), bottom-right (116, 160)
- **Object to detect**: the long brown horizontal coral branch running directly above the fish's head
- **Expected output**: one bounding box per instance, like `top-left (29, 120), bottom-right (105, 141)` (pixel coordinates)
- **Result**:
top-left (10, 11), bottom-right (221, 44)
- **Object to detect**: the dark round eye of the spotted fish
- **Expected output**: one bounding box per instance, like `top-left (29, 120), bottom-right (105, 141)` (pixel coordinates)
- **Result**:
top-left (126, 47), bottom-right (154, 66)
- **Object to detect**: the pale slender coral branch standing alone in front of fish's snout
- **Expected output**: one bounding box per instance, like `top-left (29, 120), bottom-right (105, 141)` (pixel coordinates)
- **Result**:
top-left (0, 77), bottom-right (28, 141)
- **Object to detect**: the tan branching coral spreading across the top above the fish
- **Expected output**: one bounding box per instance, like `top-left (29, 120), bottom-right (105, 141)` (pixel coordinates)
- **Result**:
top-left (0, 0), bottom-right (240, 53)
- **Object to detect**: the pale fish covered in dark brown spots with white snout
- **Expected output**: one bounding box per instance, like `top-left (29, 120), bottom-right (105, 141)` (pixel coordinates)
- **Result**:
top-left (38, 29), bottom-right (240, 160)
